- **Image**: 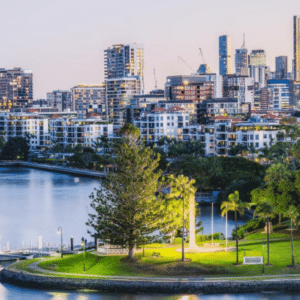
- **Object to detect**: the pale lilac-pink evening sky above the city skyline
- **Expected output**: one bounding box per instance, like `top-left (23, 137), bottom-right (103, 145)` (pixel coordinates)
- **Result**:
top-left (0, 0), bottom-right (300, 99)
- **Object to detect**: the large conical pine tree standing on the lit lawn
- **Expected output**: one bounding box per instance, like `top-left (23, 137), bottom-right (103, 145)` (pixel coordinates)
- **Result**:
top-left (86, 128), bottom-right (164, 259)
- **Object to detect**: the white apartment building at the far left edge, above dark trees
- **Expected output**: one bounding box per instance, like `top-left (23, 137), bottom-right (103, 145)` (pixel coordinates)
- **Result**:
top-left (0, 112), bottom-right (50, 150)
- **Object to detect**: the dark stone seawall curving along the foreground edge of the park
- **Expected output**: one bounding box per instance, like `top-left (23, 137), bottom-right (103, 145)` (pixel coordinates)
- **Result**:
top-left (1, 269), bottom-right (300, 294)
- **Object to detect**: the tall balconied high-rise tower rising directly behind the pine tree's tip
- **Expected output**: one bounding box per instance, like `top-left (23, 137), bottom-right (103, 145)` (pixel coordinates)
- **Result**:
top-left (104, 44), bottom-right (144, 126)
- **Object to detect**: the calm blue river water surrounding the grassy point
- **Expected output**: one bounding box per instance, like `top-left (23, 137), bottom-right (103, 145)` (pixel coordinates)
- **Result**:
top-left (0, 168), bottom-right (300, 300)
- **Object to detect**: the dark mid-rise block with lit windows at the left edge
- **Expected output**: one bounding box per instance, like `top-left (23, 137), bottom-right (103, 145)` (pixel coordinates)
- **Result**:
top-left (0, 68), bottom-right (33, 110)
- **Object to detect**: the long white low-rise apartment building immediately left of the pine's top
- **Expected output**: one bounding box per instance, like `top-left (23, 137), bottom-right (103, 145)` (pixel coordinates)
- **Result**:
top-left (50, 118), bottom-right (113, 147)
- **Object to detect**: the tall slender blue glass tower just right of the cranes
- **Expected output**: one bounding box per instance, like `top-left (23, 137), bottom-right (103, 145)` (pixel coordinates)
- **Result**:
top-left (219, 35), bottom-right (232, 75)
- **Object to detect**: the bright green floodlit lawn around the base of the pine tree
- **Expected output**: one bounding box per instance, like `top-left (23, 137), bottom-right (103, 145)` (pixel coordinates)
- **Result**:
top-left (32, 234), bottom-right (300, 277)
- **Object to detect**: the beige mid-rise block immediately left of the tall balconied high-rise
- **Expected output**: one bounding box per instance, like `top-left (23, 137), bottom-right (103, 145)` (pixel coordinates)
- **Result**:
top-left (71, 84), bottom-right (106, 118)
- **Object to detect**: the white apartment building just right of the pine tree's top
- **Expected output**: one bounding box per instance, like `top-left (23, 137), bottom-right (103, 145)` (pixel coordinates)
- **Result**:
top-left (134, 106), bottom-right (189, 142)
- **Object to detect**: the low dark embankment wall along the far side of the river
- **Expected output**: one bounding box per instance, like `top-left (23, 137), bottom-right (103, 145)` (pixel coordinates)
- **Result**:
top-left (0, 161), bottom-right (106, 179)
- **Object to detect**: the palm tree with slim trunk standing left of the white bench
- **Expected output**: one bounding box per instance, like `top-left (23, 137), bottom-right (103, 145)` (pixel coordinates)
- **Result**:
top-left (221, 191), bottom-right (251, 265)
